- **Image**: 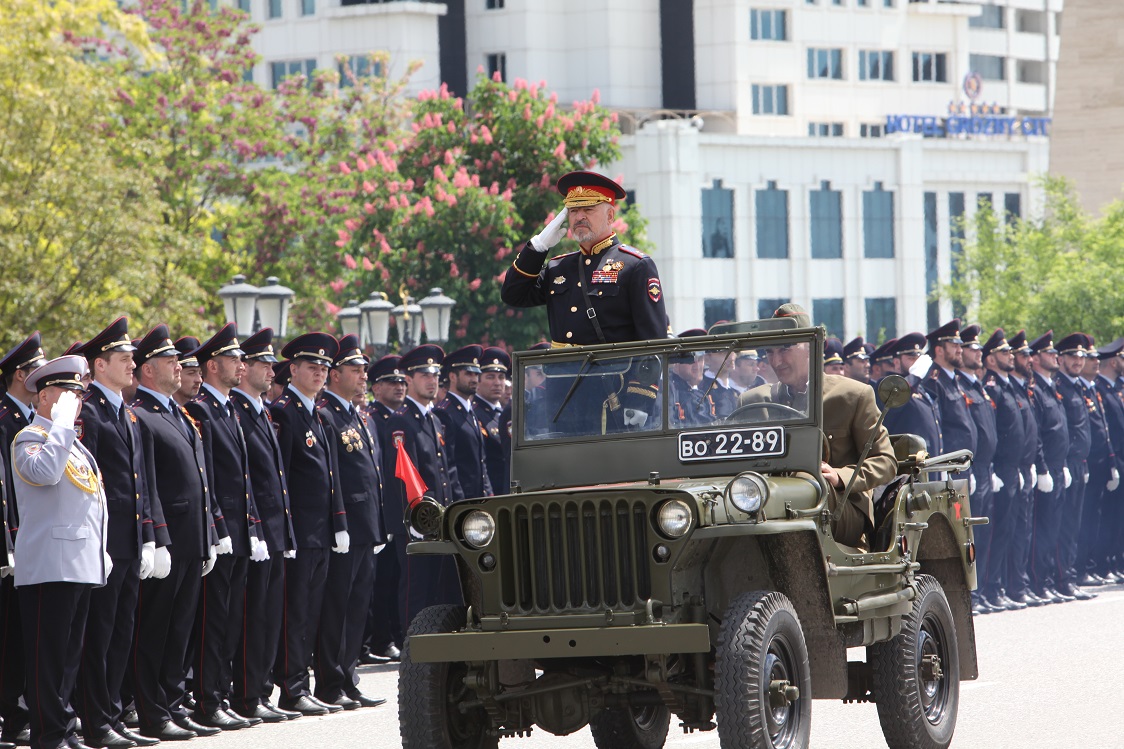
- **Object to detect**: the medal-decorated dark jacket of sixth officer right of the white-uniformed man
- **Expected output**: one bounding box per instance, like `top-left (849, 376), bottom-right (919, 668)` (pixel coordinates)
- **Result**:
top-left (317, 396), bottom-right (387, 545)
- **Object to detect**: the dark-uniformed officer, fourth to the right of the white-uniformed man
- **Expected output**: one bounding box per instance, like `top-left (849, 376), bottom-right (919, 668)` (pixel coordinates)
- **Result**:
top-left (230, 327), bottom-right (300, 723)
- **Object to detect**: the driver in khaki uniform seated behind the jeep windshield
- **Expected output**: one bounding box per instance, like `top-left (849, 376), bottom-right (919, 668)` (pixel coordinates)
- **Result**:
top-left (740, 304), bottom-right (898, 549)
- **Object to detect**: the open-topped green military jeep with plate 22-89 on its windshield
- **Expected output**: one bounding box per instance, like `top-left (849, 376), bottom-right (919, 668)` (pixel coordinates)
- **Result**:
top-left (399, 319), bottom-right (987, 749)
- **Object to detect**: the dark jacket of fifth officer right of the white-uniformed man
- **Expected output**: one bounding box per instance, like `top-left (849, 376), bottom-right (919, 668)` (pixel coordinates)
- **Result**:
top-left (270, 388), bottom-right (347, 550)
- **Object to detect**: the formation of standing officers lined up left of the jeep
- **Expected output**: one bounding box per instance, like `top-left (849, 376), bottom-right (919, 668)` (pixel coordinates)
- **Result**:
top-left (0, 317), bottom-right (511, 749)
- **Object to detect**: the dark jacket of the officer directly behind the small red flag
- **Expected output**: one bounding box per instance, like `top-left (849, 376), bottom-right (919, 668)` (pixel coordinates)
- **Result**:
top-left (383, 398), bottom-right (464, 534)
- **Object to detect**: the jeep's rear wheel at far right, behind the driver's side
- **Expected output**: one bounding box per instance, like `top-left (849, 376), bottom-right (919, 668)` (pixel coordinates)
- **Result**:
top-left (869, 575), bottom-right (960, 749)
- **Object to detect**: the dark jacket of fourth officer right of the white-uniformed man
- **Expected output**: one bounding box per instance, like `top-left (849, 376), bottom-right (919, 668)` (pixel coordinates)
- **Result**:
top-left (230, 390), bottom-right (297, 554)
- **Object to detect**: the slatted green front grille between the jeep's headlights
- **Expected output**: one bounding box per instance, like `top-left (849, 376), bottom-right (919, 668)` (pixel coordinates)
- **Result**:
top-left (498, 499), bottom-right (654, 614)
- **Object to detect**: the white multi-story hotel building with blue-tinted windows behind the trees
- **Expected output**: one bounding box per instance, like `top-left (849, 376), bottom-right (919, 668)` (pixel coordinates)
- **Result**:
top-left (242, 0), bottom-right (1062, 339)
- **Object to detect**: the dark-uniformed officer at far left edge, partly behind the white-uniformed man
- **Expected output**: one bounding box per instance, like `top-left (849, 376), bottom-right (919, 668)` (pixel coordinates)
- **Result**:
top-left (0, 331), bottom-right (46, 745)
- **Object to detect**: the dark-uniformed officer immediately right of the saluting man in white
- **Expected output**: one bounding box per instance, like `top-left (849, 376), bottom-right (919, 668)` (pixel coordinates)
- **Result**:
top-left (74, 317), bottom-right (171, 737)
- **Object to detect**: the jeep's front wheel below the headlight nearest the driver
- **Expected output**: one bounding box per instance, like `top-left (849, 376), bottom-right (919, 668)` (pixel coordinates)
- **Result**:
top-left (715, 590), bottom-right (812, 749)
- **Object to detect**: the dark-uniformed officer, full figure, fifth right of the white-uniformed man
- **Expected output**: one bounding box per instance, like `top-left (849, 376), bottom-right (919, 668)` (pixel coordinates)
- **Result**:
top-left (270, 333), bottom-right (351, 715)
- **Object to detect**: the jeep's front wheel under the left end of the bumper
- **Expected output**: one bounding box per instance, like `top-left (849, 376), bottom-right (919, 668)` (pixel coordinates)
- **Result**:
top-left (398, 605), bottom-right (499, 749)
